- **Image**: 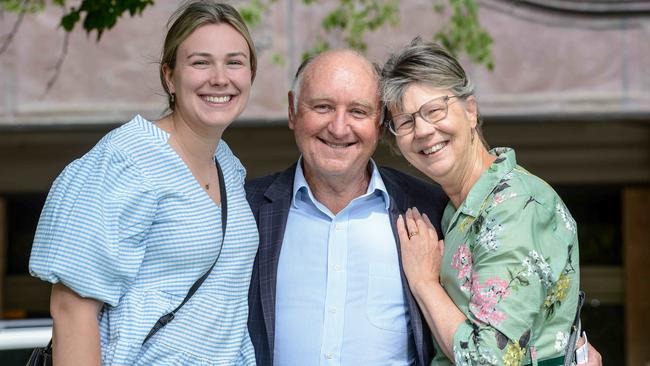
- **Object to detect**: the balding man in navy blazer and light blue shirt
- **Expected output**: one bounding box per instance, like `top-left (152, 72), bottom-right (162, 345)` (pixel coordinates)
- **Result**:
top-left (246, 50), bottom-right (447, 366)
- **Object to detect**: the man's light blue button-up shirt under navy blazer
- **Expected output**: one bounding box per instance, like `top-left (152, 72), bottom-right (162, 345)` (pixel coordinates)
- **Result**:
top-left (274, 161), bottom-right (416, 366)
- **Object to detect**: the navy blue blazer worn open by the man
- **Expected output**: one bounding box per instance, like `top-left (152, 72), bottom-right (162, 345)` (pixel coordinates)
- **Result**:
top-left (246, 164), bottom-right (448, 366)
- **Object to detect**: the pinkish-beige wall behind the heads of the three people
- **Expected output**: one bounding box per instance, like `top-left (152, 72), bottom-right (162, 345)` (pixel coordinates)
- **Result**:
top-left (0, 0), bottom-right (650, 125)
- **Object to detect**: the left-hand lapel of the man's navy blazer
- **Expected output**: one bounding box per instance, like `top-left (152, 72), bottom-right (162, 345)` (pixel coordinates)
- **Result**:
top-left (259, 165), bottom-right (296, 358)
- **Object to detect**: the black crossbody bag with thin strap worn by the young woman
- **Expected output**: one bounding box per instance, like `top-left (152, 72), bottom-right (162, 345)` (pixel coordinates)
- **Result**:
top-left (26, 161), bottom-right (228, 366)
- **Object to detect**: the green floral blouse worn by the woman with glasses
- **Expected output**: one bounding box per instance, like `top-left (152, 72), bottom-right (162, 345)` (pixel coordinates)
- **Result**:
top-left (432, 148), bottom-right (580, 366)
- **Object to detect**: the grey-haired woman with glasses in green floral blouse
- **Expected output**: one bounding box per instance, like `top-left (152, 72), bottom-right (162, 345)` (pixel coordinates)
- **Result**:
top-left (382, 39), bottom-right (579, 365)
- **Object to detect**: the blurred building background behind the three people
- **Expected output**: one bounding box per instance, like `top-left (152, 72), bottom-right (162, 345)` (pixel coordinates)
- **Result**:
top-left (0, 0), bottom-right (650, 366)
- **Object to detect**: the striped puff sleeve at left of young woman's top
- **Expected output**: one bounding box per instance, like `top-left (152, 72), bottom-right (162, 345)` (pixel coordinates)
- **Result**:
top-left (29, 142), bottom-right (156, 306)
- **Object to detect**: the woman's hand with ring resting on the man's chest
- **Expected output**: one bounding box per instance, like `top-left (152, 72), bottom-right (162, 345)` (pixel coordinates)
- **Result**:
top-left (397, 207), bottom-right (444, 293)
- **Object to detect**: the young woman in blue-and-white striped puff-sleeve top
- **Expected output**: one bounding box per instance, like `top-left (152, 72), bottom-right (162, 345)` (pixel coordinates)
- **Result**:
top-left (30, 0), bottom-right (258, 365)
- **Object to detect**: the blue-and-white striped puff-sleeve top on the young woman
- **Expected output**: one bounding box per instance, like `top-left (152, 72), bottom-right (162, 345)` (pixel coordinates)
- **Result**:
top-left (29, 116), bottom-right (258, 365)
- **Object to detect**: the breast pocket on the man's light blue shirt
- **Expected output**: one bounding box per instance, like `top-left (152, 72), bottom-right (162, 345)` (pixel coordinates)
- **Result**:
top-left (366, 263), bottom-right (409, 333)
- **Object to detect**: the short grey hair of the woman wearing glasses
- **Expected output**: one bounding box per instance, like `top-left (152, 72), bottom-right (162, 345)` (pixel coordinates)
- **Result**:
top-left (380, 37), bottom-right (488, 148)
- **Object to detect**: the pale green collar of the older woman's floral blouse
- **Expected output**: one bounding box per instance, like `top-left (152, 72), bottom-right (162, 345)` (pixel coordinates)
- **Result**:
top-left (460, 147), bottom-right (517, 217)
